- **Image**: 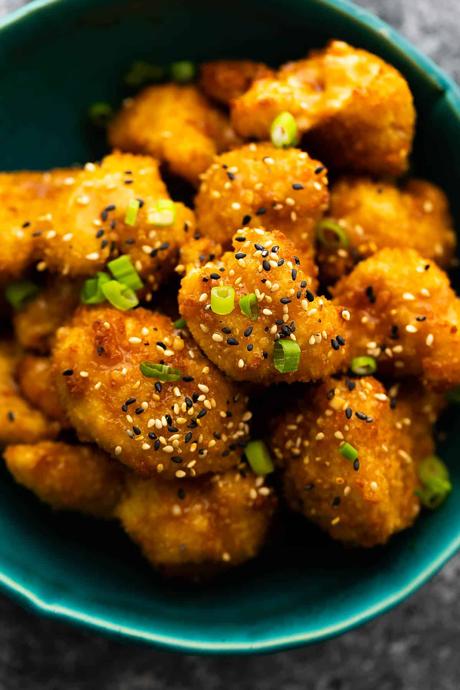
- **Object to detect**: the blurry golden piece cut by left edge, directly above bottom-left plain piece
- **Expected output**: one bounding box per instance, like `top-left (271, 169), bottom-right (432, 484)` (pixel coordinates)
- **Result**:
top-left (0, 342), bottom-right (59, 446)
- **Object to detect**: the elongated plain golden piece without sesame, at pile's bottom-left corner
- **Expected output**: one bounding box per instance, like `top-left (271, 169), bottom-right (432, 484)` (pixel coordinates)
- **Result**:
top-left (4, 441), bottom-right (124, 518)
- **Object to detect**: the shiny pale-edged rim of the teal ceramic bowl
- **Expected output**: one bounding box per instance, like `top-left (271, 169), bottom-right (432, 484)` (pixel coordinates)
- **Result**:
top-left (0, 0), bottom-right (460, 655)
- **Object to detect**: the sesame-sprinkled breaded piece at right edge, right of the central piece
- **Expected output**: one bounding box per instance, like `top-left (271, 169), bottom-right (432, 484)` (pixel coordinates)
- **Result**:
top-left (333, 249), bottom-right (460, 389)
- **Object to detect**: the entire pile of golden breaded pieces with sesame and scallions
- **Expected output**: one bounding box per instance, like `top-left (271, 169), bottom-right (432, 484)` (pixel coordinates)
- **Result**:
top-left (0, 41), bottom-right (460, 576)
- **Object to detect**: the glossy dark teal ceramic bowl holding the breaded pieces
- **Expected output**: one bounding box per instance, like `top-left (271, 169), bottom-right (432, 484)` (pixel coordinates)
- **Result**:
top-left (0, 0), bottom-right (460, 653)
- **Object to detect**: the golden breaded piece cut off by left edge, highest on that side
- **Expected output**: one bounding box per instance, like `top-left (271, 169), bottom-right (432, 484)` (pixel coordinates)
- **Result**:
top-left (0, 170), bottom-right (72, 282)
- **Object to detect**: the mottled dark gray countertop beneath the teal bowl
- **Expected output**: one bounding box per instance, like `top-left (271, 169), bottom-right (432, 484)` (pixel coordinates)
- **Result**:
top-left (0, 0), bottom-right (460, 690)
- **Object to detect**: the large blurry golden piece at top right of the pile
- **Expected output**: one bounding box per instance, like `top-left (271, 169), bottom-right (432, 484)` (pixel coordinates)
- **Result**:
top-left (232, 41), bottom-right (415, 175)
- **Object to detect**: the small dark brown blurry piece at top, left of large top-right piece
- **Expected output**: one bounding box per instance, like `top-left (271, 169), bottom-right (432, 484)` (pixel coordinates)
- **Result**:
top-left (199, 60), bottom-right (273, 105)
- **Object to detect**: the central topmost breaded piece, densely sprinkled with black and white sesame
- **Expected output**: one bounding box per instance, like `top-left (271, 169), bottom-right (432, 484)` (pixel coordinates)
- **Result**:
top-left (179, 228), bottom-right (348, 384)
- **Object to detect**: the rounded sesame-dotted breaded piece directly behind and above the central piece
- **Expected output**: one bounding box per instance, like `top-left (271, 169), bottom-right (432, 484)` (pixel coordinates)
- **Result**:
top-left (196, 143), bottom-right (329, 272)
